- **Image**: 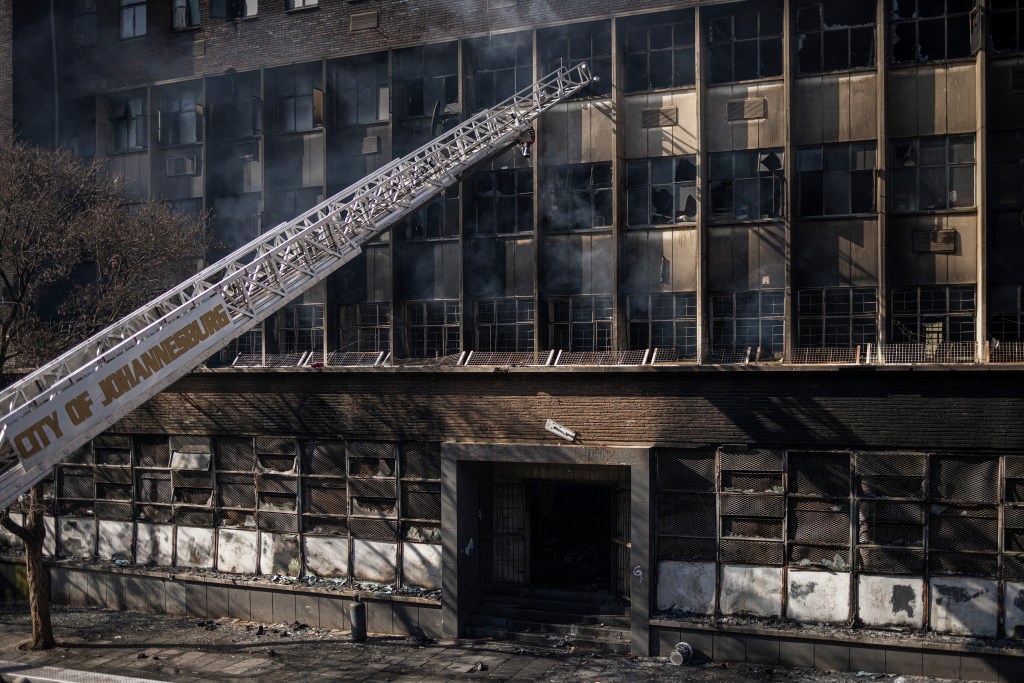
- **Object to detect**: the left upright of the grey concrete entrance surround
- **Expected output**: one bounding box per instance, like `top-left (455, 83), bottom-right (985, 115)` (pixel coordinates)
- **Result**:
top-left (441, 452), bottom-right (480, 639)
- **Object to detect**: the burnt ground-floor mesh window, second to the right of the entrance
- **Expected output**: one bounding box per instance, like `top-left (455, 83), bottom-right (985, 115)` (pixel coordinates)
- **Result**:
top-left (718, 447), bottom-right (785, 566)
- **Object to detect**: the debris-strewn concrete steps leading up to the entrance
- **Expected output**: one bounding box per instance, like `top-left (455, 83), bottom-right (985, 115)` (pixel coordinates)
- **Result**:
top-left (467, 589), bottom-right (630, 654)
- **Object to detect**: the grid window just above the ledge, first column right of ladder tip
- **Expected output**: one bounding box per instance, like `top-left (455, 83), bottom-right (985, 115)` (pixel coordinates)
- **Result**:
top-left (627, 292), bottom-right (697, 359)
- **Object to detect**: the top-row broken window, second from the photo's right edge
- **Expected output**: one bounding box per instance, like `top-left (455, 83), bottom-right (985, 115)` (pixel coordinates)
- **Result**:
top-left (892, 0), bottom-right (975, 63)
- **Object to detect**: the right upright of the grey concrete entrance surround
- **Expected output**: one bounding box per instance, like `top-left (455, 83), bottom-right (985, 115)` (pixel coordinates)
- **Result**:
top-left (629, 450), bottom-right (657, 656)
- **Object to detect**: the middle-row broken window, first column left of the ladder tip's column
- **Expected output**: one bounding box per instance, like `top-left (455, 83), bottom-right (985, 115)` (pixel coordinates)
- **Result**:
top-left (465, 167), bottom-right (534, 237)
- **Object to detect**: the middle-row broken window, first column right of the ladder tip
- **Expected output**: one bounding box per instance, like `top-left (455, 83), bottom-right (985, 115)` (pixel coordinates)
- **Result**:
top-left (626, 155), bottom-right (697, 227)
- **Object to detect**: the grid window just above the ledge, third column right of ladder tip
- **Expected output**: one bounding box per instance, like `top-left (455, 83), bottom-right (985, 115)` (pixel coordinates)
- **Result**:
top-left (797, 287), bottom-right (879, 348)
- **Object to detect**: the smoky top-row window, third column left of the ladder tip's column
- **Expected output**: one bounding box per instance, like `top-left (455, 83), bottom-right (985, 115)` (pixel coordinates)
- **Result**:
top-left (328, 52), bottom-right (391, 126)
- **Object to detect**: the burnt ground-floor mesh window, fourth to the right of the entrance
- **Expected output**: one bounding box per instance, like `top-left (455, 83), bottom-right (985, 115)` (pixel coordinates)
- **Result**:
top-left (855, 453), bottom-right (927, 575)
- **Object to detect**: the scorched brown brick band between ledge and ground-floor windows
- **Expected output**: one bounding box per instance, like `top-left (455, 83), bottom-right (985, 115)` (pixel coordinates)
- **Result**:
top-left (114, 369), bottom-right (1024, 454)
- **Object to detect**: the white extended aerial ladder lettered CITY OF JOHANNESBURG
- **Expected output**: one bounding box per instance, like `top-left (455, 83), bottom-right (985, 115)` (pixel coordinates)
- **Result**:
top-left (0, 65), bottom-right (593, 510)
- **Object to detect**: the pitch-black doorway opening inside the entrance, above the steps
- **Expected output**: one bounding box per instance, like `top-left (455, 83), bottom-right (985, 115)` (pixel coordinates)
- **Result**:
top-left (526, 481), bottom-right (614, 593)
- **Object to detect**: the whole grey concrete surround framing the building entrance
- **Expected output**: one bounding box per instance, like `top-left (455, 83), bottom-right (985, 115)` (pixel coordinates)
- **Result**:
top-left (441, 443), bottom-right (655, 656)
